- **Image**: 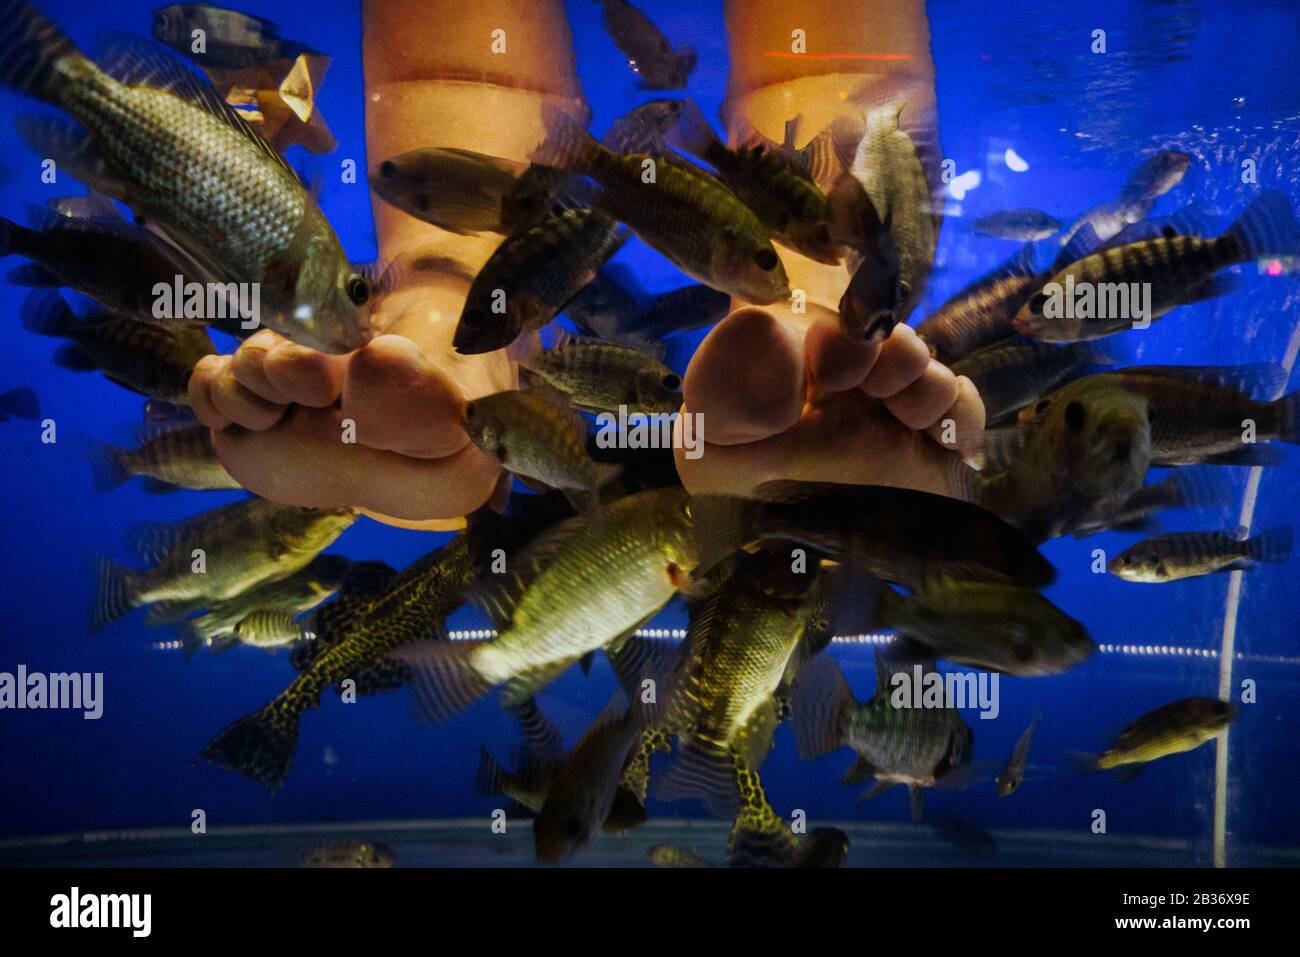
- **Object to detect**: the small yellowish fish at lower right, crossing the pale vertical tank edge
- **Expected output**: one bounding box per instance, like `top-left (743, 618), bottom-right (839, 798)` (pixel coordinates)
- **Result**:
top-left (1074, 698), bottom-right (1236, 781)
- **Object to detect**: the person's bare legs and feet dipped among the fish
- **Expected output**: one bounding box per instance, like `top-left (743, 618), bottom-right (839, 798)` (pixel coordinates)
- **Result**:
top-left (190, 0), bottom-right (984, 529)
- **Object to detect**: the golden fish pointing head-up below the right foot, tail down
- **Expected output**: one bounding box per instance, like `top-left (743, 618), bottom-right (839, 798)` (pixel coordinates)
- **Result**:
top-left (653, 553), bottom-right (818, 817)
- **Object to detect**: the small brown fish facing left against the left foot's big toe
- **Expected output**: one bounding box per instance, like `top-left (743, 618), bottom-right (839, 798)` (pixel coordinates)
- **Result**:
top-left (465, 385), bottom-right (619, 515)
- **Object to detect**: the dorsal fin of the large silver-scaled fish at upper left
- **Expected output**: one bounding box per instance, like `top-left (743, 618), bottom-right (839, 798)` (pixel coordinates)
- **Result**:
top-left (95, 33), bottom-right (300, 182)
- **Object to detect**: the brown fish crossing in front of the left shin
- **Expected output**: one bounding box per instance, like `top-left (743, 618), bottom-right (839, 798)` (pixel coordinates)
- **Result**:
top-left (369, 147), bottom-right (527, 235)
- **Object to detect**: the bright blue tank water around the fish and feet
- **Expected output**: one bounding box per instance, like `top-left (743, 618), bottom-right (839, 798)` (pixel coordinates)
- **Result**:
top-left (0, 0), bottom-right (1300, 865)
